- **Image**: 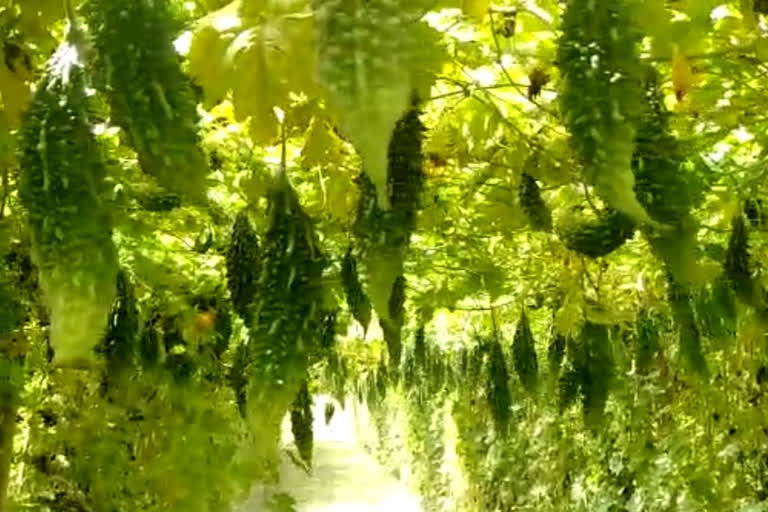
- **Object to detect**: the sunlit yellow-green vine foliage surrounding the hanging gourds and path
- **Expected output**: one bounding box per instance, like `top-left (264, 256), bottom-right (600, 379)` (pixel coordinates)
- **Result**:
top-left (0, 0), bottom-right (768, 511)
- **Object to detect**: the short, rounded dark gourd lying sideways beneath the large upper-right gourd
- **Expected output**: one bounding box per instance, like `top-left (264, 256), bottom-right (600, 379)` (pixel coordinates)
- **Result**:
top-left (555, 209), bottom-right (635, 258)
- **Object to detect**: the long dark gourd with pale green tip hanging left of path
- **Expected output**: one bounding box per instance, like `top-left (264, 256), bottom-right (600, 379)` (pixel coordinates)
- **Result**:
top-left (246, 169), bottom-right (326, 463)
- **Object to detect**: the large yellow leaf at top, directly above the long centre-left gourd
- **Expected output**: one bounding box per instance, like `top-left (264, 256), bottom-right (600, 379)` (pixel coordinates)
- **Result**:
top-left (189, 0), bottom-right (316, 143)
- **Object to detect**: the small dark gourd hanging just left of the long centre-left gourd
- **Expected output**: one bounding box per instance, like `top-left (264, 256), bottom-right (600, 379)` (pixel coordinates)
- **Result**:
top-left (226, 209), bottom-right (260, 325)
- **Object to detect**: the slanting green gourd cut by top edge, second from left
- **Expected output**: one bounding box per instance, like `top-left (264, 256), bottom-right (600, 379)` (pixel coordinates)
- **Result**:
top-left (84, 0), bottom-right (208, 201)
